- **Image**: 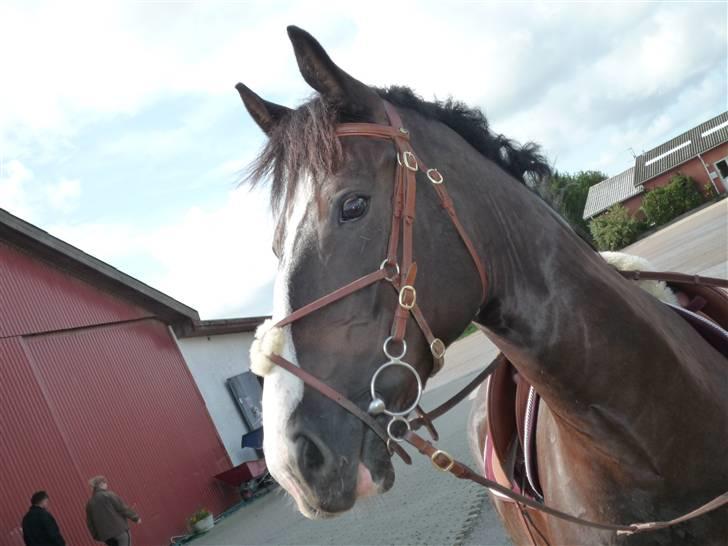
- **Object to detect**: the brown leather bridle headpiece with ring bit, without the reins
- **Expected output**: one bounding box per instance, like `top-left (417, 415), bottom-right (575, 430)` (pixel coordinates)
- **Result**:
top-left (268, 102), bottom-right (487, 464)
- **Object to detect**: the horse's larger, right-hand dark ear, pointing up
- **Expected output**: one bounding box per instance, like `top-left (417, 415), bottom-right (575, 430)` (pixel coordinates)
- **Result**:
top-left (287, 25), bottom-right (382, 115)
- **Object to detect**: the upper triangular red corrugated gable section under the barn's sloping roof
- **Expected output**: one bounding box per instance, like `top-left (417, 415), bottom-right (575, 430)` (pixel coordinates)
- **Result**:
top-left (0, 242), bottom-right (150, 338)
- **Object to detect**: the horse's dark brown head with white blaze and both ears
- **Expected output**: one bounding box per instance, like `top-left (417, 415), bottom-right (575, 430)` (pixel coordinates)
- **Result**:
top-left (237, 27), bottom-right (536, 518)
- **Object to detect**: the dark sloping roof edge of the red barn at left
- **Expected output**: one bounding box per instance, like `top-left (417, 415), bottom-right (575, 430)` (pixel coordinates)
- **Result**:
top-left (0, 209), bottom-right (200, 324)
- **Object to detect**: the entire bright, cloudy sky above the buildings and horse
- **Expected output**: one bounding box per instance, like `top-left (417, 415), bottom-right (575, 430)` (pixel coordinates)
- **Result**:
top-left (0, 0), bottom-right (728, 319)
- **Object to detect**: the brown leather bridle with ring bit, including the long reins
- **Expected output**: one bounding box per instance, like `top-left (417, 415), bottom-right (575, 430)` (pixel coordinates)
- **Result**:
top-left (258, 101), bottom-right (728, 535)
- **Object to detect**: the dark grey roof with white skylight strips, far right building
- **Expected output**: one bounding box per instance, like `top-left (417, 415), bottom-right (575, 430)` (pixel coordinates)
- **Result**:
top-left (634, 111), bottom-right (728, 186)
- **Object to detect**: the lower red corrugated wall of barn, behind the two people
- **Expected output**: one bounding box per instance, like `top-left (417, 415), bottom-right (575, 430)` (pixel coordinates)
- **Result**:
top-left (0, 319), bottom-right (235, 545)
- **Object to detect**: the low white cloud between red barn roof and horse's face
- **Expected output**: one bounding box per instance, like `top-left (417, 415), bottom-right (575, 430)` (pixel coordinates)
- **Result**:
top-left (48, 188), bottom-right (276, 318)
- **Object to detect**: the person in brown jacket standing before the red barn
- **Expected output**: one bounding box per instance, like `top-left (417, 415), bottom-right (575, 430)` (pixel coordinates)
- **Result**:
top-left (86, 476), bottom-right (142, 546)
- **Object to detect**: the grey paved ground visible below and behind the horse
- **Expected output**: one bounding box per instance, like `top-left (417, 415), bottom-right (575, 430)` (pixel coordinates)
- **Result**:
top-left (193, 199), bottom-right (728, 546)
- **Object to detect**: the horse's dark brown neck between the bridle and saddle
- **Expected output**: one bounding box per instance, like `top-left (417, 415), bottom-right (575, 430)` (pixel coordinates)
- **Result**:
top-left (451, 150), bottom-right (725, 468)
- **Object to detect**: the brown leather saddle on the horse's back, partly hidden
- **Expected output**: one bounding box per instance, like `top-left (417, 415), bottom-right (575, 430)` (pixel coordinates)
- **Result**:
top-left (484, 281), bottom-right (728, 500)
